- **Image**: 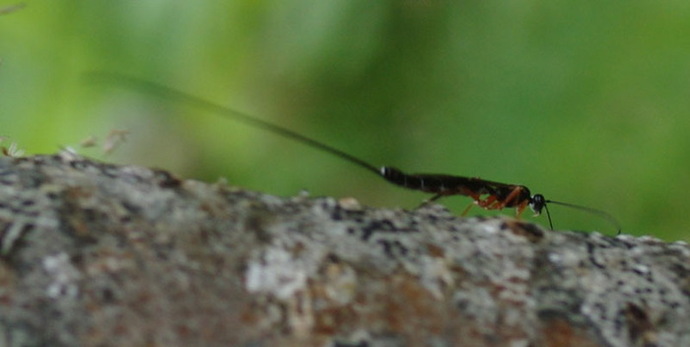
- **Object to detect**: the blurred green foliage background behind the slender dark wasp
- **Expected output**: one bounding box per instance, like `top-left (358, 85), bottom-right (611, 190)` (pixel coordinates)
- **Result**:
top-left (0, 0), bottom-right (690, 240)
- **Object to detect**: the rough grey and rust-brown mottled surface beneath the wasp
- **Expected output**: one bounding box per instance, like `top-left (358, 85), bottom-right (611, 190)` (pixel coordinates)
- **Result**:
top-left (0, 152), bottom-right (690, 346)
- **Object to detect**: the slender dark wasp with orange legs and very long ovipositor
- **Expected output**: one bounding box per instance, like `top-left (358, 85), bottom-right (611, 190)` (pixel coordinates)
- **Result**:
top-left (88, 72), bottom-right (621, 234)
